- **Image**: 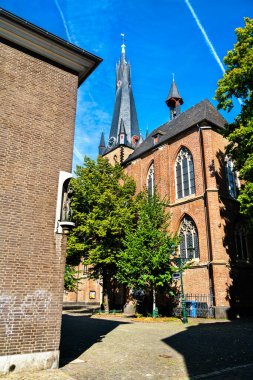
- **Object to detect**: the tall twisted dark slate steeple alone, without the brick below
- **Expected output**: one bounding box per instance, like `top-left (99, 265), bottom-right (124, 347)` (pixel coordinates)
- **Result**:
top-left (106, 35), bottom-right (140, 153)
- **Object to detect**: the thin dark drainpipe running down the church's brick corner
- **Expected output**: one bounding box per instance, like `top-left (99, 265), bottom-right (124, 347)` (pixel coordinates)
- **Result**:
top-left (197, 124), bottom-right (215, 304)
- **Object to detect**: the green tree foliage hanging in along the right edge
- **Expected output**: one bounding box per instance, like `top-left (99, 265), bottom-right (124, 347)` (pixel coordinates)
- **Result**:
top-left (215, 17), bottom-right (253, 223)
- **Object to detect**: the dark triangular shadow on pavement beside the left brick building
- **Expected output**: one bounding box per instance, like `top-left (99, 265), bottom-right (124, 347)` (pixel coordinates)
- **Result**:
top-left (60, 314), bottom-right (128, 367)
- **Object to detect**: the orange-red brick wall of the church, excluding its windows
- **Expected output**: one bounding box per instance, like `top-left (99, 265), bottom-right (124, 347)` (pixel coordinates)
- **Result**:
top-left (125, 126), bottom-right (241, 308)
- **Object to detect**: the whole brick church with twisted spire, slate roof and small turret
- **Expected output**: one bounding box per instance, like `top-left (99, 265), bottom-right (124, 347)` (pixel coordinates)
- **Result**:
top-left (99, 43), bottom-right (253, 317)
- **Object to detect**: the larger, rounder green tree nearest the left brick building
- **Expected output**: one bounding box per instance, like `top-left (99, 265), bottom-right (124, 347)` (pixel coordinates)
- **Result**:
top-left (67, 156), bottom-right (135, 311)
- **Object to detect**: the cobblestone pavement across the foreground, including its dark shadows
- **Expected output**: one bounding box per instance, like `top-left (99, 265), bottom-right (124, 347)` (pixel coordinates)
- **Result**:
top-left (1, 313), bottom-right (253, 380)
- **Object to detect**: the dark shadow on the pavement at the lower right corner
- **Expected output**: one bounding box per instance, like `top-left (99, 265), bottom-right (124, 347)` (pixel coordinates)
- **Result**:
top-left (163, 320), bottom-right (253, 379)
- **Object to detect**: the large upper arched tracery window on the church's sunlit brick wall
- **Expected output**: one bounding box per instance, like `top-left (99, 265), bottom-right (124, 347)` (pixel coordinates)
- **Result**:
top-left (176, 148), bottom-right (195, 199)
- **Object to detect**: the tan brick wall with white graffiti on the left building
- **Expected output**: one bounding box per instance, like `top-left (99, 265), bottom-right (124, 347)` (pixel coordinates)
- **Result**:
top-left (0, 40), bottom-right (78, 371)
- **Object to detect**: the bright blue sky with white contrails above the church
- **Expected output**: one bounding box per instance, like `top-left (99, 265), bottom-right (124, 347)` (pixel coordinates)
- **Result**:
top-left (0, 0), bottom-right (253, 168)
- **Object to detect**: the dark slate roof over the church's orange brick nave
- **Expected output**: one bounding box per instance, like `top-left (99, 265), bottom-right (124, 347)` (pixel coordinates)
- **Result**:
top-left (124, 99), bottom-right (227, 164)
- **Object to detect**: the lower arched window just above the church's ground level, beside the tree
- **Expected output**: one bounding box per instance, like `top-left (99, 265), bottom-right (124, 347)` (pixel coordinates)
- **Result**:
top-left (179, 216), bottom-right (199, 259)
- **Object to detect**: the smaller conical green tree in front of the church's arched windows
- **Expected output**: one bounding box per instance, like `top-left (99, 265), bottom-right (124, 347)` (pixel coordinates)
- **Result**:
top-left (116, 192), bottom-right (178, 315)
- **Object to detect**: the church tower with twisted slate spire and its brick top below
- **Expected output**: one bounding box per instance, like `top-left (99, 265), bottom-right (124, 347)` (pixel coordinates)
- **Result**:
top-left (99, 35), bottom-right (142, 163)
